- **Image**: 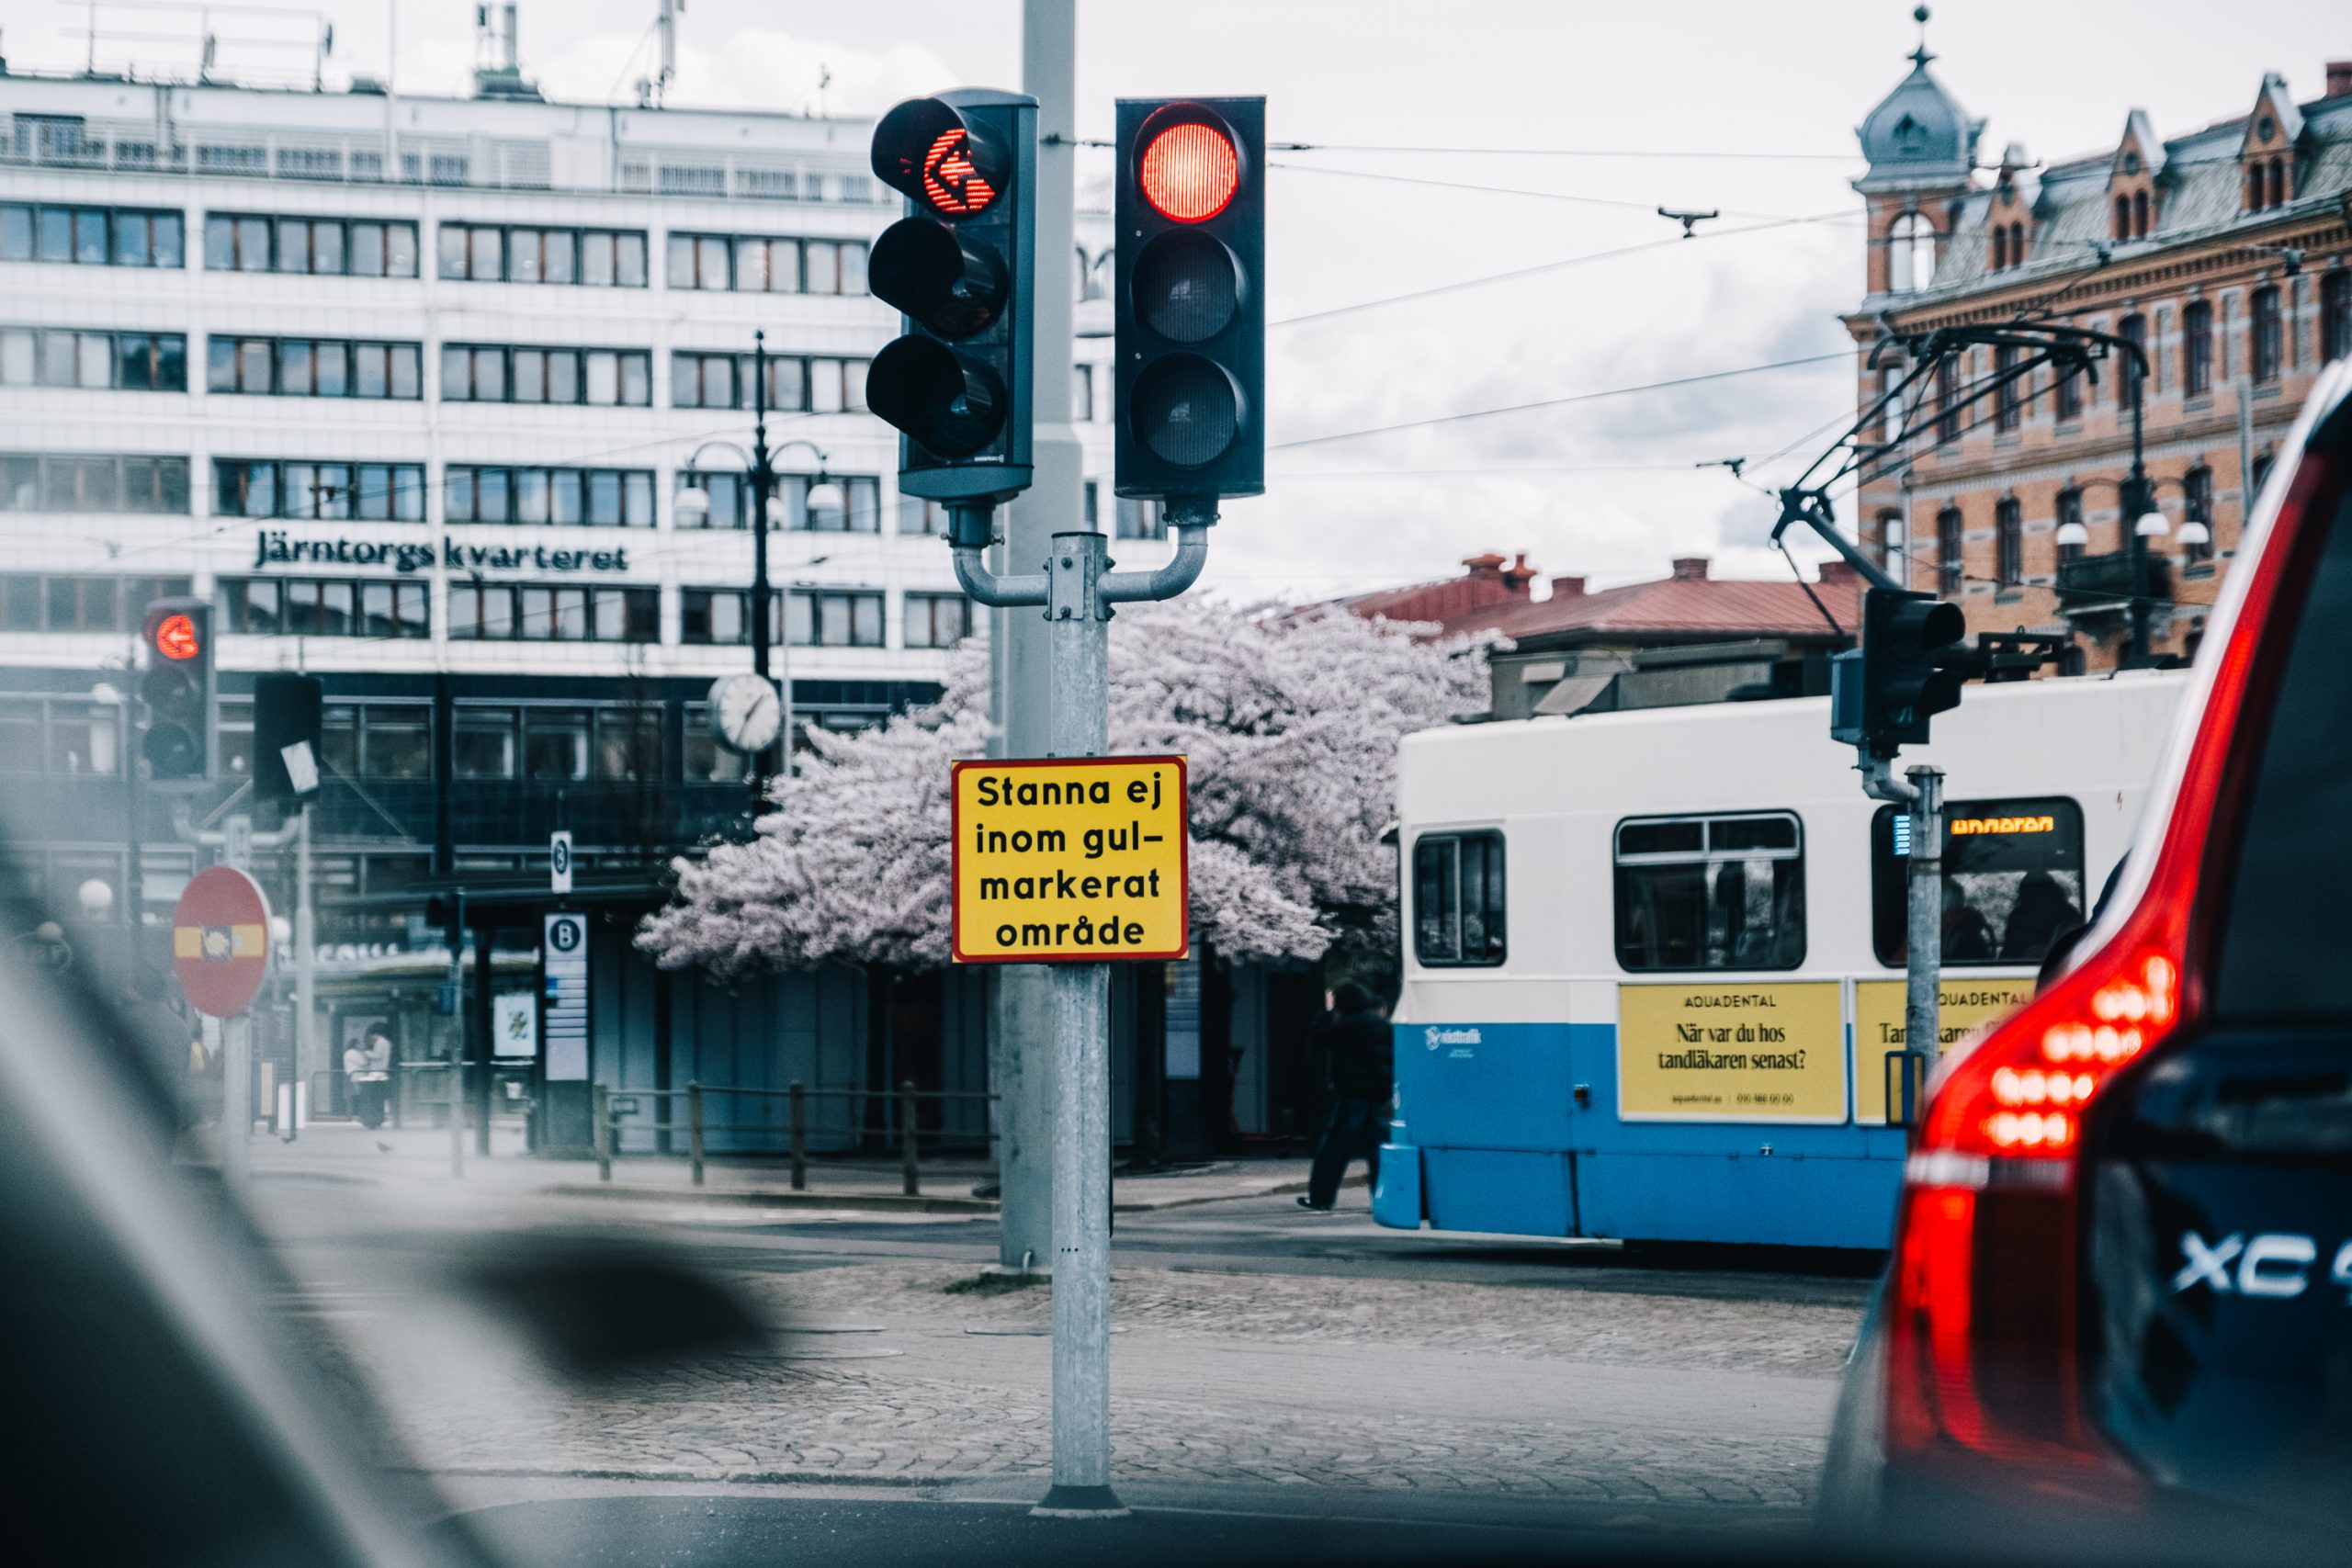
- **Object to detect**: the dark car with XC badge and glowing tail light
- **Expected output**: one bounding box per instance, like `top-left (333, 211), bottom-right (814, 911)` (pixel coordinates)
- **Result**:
top-left (1826, 367), bottom-right (2352, 1556)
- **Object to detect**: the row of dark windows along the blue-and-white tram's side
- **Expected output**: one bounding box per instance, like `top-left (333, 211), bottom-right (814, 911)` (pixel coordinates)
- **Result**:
top-left (1411, 797), bottom-right (2086, 974)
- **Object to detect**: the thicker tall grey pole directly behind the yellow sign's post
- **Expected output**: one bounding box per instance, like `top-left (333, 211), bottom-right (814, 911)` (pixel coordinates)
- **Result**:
top-left (988, 0), bottom-right (1087, 1269)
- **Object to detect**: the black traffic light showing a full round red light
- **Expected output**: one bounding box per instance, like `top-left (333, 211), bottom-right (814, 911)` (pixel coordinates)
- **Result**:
top-left (1113, 98), bottom-right (1265, 501)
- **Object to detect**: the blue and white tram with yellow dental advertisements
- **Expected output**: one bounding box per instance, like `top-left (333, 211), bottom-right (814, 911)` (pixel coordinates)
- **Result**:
top-left (1374, 672), bottom-right (2188, 1248)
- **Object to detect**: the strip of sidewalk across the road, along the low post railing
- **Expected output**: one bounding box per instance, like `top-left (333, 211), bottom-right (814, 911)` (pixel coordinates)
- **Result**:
top-left (254, 1122), bottom-right (1364, 1215)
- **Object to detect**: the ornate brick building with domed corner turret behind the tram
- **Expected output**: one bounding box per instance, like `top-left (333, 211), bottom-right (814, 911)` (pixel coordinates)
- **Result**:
top-left (1844, 45), bottom-right (2352, 670)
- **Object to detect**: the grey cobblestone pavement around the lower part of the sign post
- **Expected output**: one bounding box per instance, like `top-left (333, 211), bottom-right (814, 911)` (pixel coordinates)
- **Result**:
top-left (344, 1262), bottom-right (1858, 1506)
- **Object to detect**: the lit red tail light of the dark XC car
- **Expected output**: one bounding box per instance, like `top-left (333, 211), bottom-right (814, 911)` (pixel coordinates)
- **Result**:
top-left (1886, 415), bottom-right (2331, 1506)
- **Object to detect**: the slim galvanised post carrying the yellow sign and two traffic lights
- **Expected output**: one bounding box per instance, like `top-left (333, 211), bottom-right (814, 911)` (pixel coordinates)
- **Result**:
top-left (1037, 534), bottom-right (1126, 1514)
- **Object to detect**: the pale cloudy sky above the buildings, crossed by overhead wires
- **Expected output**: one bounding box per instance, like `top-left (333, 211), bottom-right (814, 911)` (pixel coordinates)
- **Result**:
top-left (18, 0), bottom-right (2352, 597)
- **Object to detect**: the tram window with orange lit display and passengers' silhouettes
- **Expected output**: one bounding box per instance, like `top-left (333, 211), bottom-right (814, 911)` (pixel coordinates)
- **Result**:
top-left (1870, 795), bottom-right (2086, 968)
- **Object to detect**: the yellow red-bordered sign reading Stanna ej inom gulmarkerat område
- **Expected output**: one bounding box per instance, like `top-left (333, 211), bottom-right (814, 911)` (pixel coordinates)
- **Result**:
top-left (953, 757), bottom-right (1190, 964)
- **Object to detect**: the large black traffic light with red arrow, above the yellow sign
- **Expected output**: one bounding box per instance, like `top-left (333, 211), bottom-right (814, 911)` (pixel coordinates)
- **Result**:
top-left (865, 87), bottom-right (1035, 503)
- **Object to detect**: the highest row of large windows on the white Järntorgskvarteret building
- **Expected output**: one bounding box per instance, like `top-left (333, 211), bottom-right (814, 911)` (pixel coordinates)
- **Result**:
top-left (0, 202), bottom-right (865, 294)
